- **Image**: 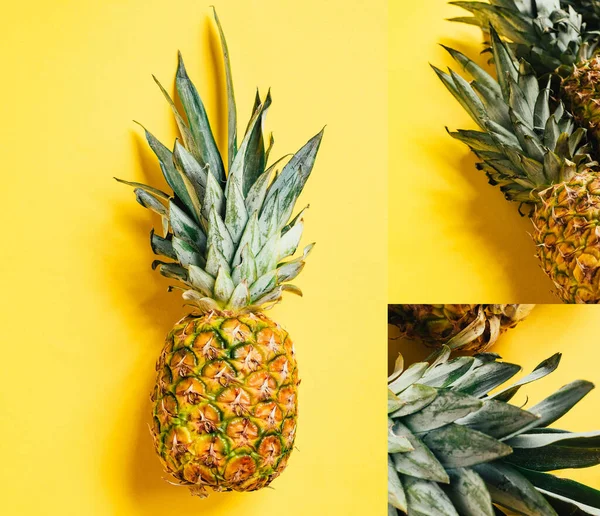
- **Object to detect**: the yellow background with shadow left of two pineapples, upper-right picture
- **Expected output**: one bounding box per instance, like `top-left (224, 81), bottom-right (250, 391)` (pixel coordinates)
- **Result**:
top-left (388, 0), bottom-right (558, 303)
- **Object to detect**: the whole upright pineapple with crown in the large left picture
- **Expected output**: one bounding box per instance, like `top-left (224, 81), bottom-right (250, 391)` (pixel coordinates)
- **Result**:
top-left (120, 12), bottom-right (323, 497)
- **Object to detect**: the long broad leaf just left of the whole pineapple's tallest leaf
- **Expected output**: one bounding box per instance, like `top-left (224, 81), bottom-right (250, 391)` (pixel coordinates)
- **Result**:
top-left (175, 53), bottom-right (225, 183)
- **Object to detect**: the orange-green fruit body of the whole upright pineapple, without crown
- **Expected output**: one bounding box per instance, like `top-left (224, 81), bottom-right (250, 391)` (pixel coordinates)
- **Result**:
top-left (151, 311), bottom-right (299, 497)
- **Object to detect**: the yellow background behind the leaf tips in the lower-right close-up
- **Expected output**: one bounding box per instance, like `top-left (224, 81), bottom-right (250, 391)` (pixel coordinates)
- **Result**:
top-left (388, 304), bottom-right (600, 489)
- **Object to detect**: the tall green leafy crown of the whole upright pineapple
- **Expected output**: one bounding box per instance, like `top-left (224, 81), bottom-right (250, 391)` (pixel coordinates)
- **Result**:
top-left (118, 11), bottom-right (323, 312)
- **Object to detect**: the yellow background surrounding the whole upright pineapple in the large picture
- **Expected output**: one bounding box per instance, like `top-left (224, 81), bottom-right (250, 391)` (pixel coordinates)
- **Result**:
top-left (0, 0), bottom-right (387, 516)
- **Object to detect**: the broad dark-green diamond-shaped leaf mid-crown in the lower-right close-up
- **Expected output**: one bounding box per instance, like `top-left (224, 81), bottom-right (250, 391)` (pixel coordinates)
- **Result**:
top-left (423, 423), bottom-right (512, 468)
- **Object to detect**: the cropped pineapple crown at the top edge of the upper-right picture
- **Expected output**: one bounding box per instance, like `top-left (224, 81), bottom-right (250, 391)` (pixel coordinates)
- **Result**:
top-left (451, 0), bottom-right (599, 74)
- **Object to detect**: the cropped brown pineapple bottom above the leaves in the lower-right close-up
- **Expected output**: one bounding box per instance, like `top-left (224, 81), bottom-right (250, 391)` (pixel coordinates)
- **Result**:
top-left (388, 304), bottom-right (535, 352)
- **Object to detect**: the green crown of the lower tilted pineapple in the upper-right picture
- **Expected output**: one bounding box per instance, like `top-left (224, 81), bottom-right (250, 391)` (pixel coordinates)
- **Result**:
top-left (433, 26), bottom-right (595, 211)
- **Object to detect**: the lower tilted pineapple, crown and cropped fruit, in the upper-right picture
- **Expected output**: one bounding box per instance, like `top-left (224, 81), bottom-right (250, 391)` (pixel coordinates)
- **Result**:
top-left (434, 27), bottom-right (600, 303)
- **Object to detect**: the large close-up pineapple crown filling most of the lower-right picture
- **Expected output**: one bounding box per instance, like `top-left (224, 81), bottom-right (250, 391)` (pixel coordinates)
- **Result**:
top-left (388, 346), bottom-right (600, 516)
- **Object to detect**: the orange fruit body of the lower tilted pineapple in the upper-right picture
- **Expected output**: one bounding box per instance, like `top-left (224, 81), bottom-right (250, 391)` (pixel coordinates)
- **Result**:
top-left (532, 170), bottom-right (600, 304)
